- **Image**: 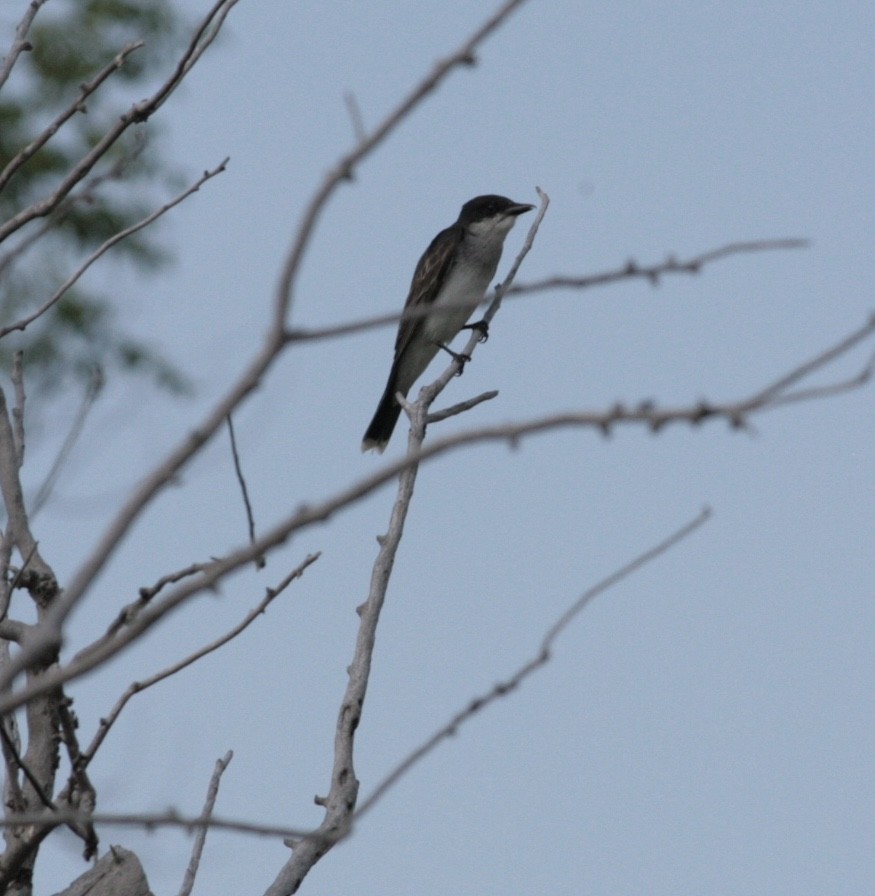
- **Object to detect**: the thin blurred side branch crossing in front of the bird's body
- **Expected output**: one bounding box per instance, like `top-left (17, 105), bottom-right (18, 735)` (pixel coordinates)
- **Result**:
top-left (285, 239), bottom-right (808, 343)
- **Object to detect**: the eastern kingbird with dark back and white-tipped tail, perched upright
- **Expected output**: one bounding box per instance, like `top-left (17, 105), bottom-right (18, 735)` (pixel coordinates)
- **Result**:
top-left (362, 196), bottom-right (534, 453)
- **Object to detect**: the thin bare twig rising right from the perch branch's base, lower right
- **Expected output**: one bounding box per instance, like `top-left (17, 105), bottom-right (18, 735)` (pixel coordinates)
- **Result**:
top-left (355, 508), bottom-right (711, 821)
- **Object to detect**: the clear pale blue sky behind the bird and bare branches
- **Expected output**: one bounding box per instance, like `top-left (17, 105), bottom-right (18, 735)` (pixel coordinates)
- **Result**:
top-left (28, 0), bottom-right (875, 896)
